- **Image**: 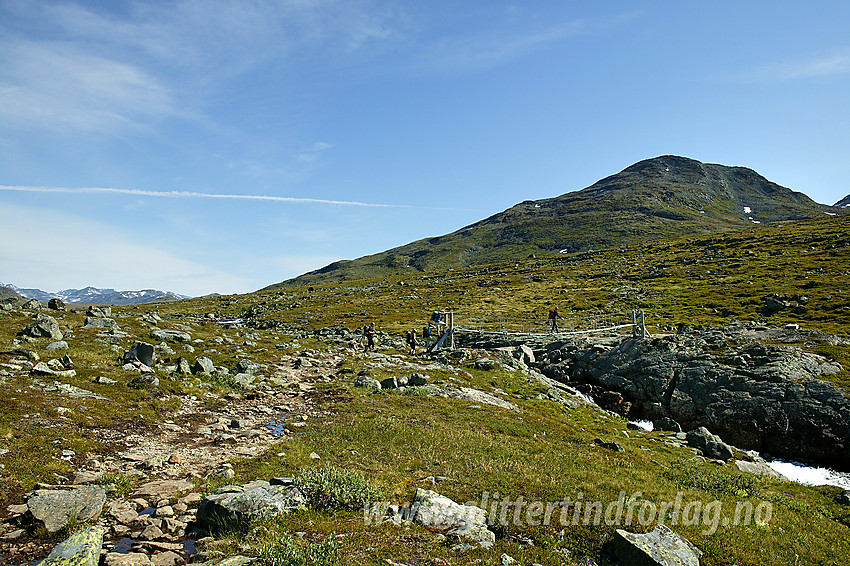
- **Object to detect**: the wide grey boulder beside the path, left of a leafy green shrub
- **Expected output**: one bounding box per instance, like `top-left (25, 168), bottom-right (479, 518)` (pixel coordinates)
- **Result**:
top-left (196, 485), bottom-right (307, 531)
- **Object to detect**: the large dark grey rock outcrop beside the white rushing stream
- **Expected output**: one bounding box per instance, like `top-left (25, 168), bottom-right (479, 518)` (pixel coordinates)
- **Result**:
top-left (539, 327), bottom-right (850, 469)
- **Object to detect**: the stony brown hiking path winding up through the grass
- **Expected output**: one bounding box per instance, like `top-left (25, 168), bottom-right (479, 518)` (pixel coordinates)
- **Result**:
top-left (0, 350), bottom-right (344, 566)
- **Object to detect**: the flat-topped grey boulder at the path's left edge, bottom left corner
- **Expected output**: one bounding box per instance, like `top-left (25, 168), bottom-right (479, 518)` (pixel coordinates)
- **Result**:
top-left (27, 485), bottom-right (106, 533)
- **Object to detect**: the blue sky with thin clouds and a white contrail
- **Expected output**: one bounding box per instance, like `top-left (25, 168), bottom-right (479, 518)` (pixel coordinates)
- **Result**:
top-left (0, 0), bottom-right (850, 295)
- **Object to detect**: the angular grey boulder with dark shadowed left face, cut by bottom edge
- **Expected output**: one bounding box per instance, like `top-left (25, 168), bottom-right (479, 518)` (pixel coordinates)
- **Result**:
top-left (608, 525), bottom-right (703, 566)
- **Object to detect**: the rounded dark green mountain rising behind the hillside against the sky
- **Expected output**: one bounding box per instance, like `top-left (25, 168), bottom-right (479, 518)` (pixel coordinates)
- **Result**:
top-left (272, 155), bottom-right (835, 288)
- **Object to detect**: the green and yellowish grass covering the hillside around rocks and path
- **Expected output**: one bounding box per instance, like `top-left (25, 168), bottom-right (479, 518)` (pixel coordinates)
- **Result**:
top-left (0, 218), bottom-right (850, 566)
